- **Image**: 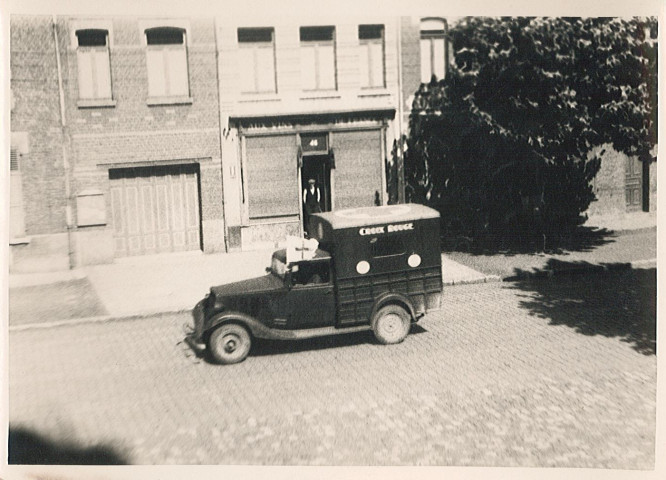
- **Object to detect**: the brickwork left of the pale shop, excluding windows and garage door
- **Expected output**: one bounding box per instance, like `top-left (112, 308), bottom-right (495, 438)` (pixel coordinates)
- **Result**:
top-left (11, 16), bottom-right (224, 257)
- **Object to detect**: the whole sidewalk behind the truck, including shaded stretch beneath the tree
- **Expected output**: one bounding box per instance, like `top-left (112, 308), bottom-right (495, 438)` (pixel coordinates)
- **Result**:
top-left (9, 214), bottom-right (656, 329)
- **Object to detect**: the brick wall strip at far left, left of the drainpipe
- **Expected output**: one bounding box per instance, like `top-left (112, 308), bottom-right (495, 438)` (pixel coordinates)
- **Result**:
top-left (10, 16), bottom-right (66, 235)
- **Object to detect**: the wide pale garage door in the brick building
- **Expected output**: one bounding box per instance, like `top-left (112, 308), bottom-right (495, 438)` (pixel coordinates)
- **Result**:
top-left (109, 165), bottom-right (200, 256)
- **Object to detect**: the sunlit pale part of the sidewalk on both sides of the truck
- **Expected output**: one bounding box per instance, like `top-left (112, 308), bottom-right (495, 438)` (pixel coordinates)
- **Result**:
top-left (9, 250), bottom-right (492, 326)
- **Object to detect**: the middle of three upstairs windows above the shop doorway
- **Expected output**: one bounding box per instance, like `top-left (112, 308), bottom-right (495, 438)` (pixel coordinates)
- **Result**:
top-left (300, 27), bottom-right (336, 90)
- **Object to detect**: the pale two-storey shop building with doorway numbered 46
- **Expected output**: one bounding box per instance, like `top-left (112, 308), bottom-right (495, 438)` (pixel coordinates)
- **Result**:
top-left (217, 17), bottom-right (400, 249)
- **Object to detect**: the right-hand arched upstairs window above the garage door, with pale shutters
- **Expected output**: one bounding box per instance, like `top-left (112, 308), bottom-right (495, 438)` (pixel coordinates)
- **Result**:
top-left (145, 27), bottom-right (189, 97)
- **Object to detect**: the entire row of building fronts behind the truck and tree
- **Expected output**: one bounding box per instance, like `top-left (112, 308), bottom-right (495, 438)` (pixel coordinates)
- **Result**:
top-left (10, 15), bottom-right (656, 271)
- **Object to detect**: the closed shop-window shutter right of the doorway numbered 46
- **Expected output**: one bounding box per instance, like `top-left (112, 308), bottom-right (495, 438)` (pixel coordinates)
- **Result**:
top-left (331, 130), bottom-right (384, 210)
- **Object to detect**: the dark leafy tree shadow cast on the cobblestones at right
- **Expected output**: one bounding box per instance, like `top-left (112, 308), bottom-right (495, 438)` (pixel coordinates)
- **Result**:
top-left (511, 259), bottom-right (657, 355)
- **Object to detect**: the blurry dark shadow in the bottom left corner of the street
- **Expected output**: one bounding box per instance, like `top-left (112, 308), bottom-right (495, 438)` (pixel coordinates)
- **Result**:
top-left (8, 427), bottom-right (129, 465)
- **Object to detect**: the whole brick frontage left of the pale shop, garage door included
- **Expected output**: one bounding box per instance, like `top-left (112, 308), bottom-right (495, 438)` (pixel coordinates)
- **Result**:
top-left (11, 16), bottom-right (225, 269)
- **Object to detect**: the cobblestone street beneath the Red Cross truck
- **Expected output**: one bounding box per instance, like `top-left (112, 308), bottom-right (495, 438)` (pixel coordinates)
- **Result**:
top-left (9, 269), bottom-right (657, 469)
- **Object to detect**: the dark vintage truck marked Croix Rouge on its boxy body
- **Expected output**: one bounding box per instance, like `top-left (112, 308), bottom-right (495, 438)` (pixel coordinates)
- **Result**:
top-left (188, 204), bottom-right (442, 364)
